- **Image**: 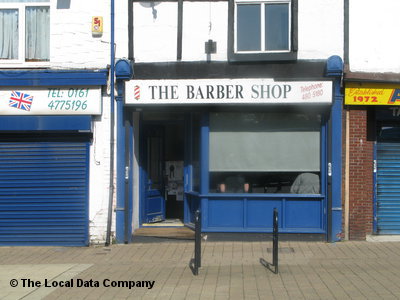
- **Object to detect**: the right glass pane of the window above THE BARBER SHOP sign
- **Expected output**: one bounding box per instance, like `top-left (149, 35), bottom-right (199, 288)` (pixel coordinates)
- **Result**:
top-left (265, 4), bottom-right (289, 50)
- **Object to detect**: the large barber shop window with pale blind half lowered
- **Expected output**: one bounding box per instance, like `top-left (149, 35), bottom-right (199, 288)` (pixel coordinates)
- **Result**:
top-left (209, 113), bottom-right (321, 194)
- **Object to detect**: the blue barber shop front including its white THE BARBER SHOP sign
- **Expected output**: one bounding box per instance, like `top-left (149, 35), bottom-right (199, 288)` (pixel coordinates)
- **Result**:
top-left (117, 58), bottom-right (342, 241)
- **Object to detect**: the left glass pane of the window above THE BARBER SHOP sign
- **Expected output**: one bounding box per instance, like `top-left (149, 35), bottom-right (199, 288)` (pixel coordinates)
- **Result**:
top-left (236, 4), bottom-right (261, 51)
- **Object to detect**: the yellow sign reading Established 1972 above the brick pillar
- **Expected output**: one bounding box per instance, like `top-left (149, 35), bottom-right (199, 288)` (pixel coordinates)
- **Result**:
top-left (344, 82), bottom-right (400, 105)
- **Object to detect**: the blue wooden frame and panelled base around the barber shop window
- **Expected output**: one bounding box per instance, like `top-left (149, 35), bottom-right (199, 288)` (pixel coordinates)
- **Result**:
top-left (197, 113), bottom-right (327, 234)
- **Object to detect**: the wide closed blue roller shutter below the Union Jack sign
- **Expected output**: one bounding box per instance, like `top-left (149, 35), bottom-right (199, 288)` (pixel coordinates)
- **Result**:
top-left (0, 137), bottom-right (89, 246)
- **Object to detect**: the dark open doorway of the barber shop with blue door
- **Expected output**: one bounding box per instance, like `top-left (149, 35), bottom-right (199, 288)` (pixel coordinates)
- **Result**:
top-left (141, 115), bottom-right (185, 223)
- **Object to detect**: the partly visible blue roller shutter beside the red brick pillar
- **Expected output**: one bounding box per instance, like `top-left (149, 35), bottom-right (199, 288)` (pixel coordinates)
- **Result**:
top-left (376, 142), bottom-right (400, 234)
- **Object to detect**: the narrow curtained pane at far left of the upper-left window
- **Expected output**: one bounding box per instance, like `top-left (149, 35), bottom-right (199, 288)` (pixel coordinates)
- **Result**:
top-left (0, 9), bottom-right (18, 59)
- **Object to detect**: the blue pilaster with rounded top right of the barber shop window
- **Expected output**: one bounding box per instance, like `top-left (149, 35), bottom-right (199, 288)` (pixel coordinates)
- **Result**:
top-left (325, 55), bottom-right (343, 242)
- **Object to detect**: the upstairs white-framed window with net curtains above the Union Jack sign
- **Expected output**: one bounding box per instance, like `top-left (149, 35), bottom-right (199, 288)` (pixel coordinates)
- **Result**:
top-left (0, 0), bottom-right (50, 63)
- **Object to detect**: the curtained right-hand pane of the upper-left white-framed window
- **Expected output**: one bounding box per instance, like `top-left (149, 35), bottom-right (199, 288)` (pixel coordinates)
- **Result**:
top-left (25, 6), bottom-right (50, 60)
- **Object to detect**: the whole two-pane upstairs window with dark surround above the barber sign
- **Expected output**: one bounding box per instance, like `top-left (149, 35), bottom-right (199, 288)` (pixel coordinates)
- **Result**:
top-left (229, 0), bottom-right (297, 60)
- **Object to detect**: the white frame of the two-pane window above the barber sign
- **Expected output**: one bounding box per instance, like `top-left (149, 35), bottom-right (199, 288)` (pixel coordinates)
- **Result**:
top-left (234, 0), bottom-right (292, 54)
